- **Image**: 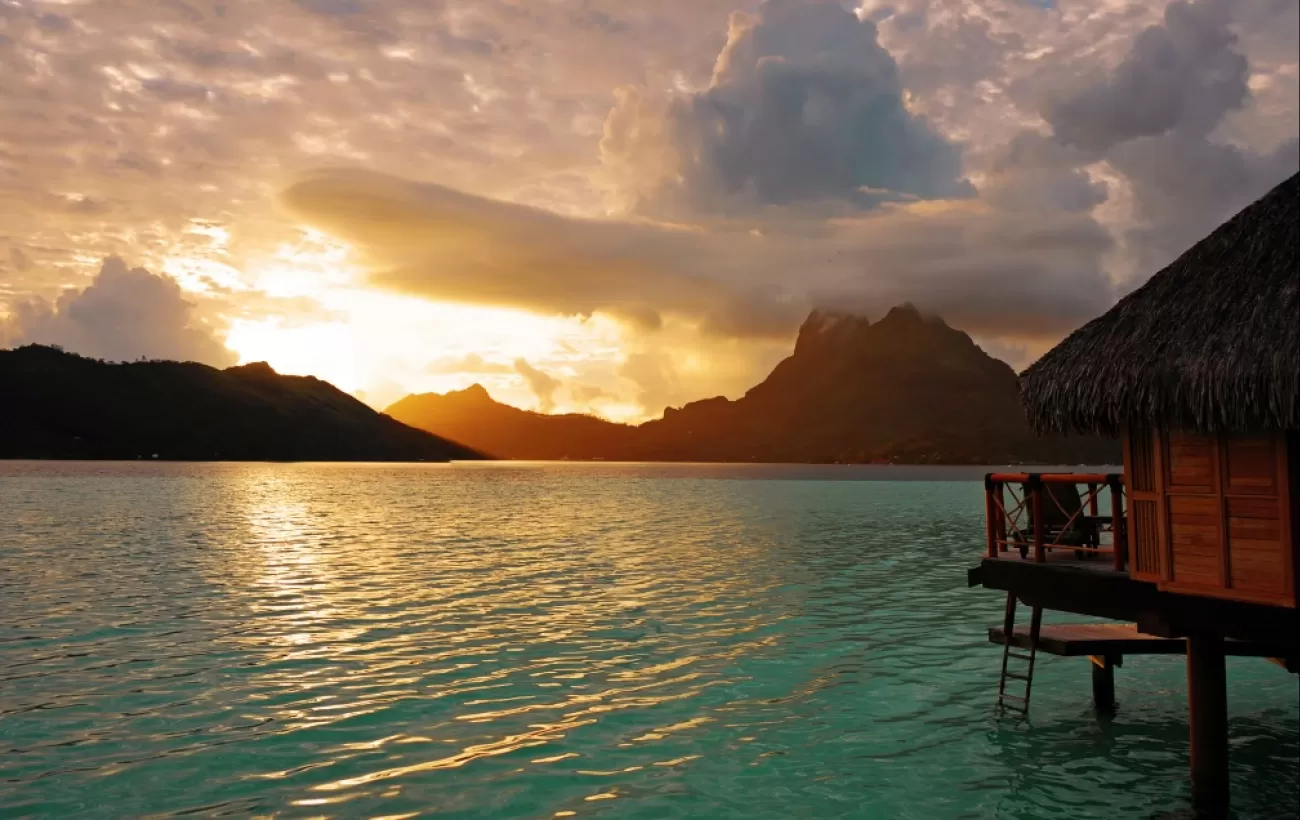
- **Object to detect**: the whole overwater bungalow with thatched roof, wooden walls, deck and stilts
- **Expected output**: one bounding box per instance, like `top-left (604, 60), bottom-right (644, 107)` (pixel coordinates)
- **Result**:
top-left (969, 175), bottom-right (1300, 815)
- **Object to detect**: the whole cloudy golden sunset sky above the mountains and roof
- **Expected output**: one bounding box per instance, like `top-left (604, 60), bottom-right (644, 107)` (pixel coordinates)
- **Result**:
top-left (0, 0), bottom-right (1300, 421)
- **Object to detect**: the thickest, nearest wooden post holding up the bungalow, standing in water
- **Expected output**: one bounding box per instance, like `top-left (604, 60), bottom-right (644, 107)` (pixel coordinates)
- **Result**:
top-left (1187, 633), bottom-right (1229, 817)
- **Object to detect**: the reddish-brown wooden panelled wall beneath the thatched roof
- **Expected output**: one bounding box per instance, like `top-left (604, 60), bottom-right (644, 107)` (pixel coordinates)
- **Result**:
top-left (1125, 430), bottom-right (1300, 607)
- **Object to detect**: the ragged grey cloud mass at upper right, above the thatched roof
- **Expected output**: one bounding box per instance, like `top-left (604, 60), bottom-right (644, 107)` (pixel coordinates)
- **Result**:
top-left (1028, 0), bottom-right (1300, 279)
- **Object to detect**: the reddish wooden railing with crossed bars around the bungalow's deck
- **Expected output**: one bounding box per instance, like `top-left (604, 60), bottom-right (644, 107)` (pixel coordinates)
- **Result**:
top-left (984, 473), bottom-right (1128, 572)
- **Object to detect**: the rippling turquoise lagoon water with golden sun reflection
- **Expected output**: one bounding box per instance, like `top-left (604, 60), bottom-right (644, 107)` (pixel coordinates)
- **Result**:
top-left (0, 463), bottom-right (1300, 819)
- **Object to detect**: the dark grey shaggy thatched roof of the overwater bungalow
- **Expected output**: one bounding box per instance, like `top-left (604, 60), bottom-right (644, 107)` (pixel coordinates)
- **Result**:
top-left (1021, 174), bottom-right (1300, 435)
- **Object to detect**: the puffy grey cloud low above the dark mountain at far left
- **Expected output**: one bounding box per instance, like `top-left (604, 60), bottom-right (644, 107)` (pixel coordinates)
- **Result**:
top-left (5, 256), bottom-right (235, 366)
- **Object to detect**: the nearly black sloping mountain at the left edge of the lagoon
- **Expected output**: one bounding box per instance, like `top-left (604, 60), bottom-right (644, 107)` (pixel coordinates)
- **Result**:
top-left (0, 344), bottom-right (481, 461)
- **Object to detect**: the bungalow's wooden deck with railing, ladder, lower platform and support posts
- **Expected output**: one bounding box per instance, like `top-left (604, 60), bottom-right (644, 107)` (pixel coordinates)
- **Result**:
top-left (967, 473), bottom-right (1300, 811)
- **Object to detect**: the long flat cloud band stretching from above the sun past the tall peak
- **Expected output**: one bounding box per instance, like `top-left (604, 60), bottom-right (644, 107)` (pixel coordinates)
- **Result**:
top-left (282, 172), bottom-right (1112, 338)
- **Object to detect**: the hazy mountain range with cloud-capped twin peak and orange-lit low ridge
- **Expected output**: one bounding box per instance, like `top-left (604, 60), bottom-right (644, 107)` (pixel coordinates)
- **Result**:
top-left (387, 305), bottom-right (1119, 464)
